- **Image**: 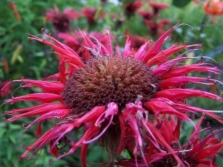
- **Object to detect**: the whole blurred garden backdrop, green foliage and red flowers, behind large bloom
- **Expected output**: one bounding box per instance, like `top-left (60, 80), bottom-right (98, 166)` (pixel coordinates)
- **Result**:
top-left (0, 0), bottom-right (223, 167)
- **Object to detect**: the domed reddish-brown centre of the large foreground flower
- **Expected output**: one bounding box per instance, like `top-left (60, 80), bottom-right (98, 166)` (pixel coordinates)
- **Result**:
top-left (63, 56), bottom-right (158, 113)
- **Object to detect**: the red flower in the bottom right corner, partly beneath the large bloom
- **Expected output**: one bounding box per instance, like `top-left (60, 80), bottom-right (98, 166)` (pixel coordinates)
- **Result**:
top-left (115, 116), bottom-right (223, 167)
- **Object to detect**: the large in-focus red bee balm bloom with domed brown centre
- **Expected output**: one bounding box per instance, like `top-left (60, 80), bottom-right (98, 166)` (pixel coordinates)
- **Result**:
top-left (2, 25), bottom-right (223, 167)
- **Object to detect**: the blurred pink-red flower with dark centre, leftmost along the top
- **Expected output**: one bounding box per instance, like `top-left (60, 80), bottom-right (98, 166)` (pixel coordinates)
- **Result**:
top-left (46, 6), bottom-right (79, 32)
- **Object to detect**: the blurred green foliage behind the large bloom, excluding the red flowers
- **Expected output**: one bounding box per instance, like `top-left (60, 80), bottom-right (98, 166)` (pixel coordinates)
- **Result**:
top-left (0, 0), bottom-right (223, 167)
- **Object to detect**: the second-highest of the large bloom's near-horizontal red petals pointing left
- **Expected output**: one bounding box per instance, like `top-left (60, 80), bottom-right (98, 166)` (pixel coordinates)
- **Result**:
top-left (5, 93), bottom-right (62, 103)
